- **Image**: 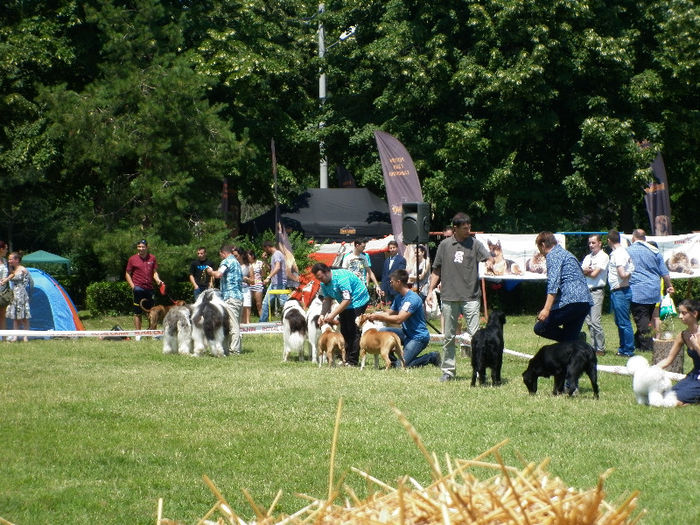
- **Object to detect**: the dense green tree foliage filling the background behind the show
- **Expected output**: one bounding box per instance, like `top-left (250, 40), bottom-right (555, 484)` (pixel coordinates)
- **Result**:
top-left (0, 0), bottom-right (700, 282)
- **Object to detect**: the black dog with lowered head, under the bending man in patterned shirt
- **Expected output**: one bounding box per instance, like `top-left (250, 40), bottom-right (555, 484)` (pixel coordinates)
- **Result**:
top-left (523, 341), bottom-right (598, 399)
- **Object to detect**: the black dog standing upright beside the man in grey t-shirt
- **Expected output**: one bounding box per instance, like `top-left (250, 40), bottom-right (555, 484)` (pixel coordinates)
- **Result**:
top-left (472, 310), bottom-right (506, 386)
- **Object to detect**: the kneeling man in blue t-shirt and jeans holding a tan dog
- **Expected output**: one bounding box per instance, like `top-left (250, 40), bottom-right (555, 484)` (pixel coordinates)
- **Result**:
top-left (369, 270), bottom-right (440, 367)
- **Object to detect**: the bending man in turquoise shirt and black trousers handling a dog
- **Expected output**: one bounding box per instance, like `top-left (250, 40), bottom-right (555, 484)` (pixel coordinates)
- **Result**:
top-left (311, 263), bottom-right (369, 366)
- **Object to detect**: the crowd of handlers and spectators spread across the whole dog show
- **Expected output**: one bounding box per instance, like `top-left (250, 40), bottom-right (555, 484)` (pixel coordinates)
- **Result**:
top-left (0, 217), bottom-right (700, 403)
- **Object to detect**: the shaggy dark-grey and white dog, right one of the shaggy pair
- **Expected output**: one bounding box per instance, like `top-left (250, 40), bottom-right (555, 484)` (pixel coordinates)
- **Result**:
top-left (192, 288), bottom-right (229, 357)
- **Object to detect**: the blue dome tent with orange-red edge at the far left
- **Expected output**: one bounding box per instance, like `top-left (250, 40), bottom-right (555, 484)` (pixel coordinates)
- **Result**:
top-left (7, 268), bottom-right (85, 330)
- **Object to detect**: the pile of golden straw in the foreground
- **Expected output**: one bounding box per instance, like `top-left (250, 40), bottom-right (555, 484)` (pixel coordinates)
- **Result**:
top-left (156, 400), bottom-right (644, 525)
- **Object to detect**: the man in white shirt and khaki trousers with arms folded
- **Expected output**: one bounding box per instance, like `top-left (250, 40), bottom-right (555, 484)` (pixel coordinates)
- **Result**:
top-left (581, 233), bottom-right (609, 355)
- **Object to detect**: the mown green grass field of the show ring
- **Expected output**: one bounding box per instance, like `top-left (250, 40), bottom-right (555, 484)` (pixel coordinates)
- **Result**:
top-left (0, 316), bottom-right (700, 525)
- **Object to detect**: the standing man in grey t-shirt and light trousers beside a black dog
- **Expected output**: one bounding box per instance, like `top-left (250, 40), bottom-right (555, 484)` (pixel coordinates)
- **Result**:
top-left (426, 212), bottom-right (493, 381)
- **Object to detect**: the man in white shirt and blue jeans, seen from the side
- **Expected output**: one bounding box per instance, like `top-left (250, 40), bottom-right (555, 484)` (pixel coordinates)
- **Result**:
top-left (608, 230), bottom-right (634, 357)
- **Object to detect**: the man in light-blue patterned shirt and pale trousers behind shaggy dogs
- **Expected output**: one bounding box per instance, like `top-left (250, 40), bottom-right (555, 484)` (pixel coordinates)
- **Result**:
top-left (206, 244), bottom-right (243, 355)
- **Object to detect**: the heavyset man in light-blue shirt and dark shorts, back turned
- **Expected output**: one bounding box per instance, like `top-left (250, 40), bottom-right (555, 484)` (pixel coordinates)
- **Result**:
top-left (627, 229), bottom-right (674, 351)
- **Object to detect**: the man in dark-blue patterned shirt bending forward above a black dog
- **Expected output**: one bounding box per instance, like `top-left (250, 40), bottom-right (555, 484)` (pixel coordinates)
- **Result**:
top-left (534, 232), bottom-right (593, 342)
